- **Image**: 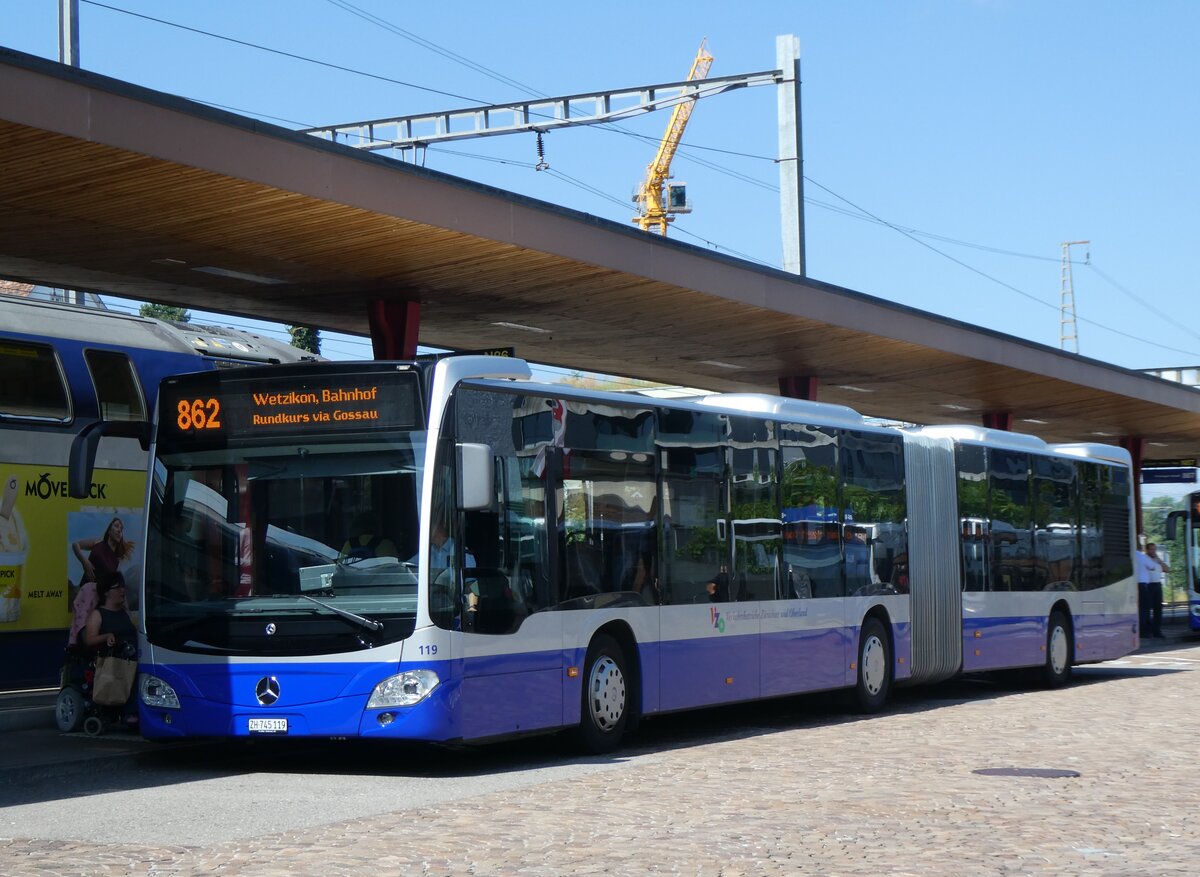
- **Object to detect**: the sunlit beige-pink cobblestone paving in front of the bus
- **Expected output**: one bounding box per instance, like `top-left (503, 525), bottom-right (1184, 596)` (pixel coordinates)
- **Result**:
top-left (0, 647), bottom-right (1200, 877)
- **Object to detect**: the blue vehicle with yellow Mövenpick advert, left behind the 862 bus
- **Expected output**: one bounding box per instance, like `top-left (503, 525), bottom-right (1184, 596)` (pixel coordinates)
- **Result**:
top-left (0, 295), bottom-right (319, 690)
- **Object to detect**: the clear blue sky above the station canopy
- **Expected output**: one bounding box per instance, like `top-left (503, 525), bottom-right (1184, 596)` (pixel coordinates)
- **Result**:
top-left (0, 0), bottom-right (1200, 368)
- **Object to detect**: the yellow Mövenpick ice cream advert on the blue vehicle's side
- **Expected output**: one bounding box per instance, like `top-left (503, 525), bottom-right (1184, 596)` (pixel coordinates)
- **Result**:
top-left (0, 463), bottom-right (145, 633)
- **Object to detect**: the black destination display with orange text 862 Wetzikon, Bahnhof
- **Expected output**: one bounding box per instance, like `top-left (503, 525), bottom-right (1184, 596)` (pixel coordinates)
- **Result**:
top-left (158, 373), bottom-right (418, 441)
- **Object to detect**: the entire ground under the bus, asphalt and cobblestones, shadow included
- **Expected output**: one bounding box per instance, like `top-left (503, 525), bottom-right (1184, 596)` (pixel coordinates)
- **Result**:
top-left (0, 642), bottom-right (1200, 877)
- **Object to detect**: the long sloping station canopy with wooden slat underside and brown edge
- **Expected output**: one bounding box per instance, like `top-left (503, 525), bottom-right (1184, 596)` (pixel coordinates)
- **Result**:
top-left (7, 49), bottom-right (1200, 458)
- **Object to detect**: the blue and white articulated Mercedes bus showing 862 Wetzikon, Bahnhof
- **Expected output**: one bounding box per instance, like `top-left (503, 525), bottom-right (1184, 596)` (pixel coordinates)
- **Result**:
top-left (71, 356), bottom-right (1138, 752)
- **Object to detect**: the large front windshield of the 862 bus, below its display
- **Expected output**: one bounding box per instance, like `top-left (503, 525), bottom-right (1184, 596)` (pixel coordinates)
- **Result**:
top-left (144, 432), bottom-right (425, 654)
